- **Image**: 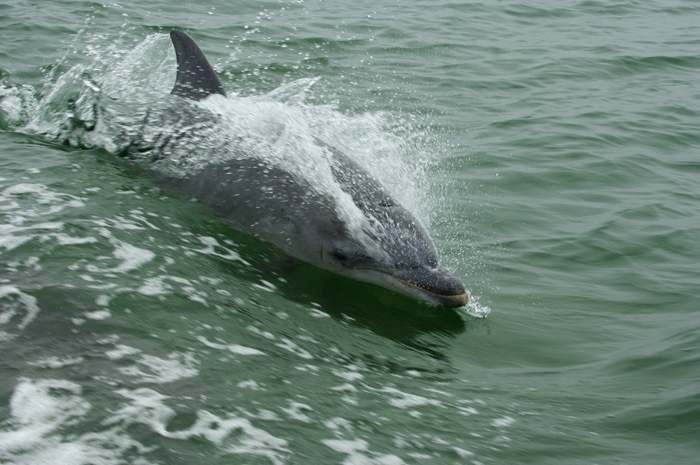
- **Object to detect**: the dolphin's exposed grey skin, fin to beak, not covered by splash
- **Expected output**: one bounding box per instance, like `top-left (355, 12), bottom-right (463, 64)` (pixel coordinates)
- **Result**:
top-left (156, 30), bottom-right (468, 307)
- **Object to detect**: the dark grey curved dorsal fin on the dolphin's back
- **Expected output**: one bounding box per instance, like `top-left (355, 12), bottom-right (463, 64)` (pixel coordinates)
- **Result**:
top-left (170, 30), bottom-right (226, 100)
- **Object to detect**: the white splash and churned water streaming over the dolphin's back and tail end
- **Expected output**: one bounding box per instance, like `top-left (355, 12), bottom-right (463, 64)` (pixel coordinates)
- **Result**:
top-left (3, 29), bottom-right (484, 316)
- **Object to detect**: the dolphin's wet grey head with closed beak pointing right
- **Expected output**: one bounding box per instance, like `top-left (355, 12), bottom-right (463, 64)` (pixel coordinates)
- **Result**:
top-left (302, 140), bottom-right (469, 307)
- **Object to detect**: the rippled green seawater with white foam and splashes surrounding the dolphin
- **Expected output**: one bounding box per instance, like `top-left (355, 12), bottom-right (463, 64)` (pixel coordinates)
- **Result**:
top-left (0, 0), bottom-right (700, 465)
